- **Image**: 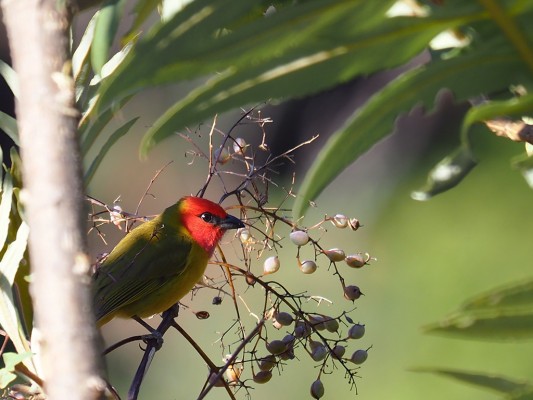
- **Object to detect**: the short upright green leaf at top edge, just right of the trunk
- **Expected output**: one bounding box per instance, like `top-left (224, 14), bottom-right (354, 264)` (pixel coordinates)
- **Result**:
top-left (91, 0), bottom-right (126, 74)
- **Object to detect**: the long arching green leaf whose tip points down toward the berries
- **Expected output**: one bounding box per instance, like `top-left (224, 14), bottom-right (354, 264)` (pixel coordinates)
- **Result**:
top-left (294, 42), bottom-right (527, 216)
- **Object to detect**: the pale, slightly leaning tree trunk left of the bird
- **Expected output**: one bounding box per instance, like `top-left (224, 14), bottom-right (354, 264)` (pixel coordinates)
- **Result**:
top-left (1, 0), bottom-right (105, 400)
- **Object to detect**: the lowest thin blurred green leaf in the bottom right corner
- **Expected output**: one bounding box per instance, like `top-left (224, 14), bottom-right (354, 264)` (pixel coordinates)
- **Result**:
top-left (413, 368), bottom-right (533, 394)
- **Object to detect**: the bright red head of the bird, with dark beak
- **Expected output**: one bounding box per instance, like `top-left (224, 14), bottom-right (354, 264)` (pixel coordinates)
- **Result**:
top-left (179, 196), bottom-right (244, 254)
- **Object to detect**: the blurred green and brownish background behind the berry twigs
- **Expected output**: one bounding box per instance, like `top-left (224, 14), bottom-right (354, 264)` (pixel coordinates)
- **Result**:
top-left (90, 86), bottom-right (533, 400)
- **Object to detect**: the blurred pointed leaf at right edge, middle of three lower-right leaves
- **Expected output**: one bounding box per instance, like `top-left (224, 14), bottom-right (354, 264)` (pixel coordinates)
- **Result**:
top-left (424, 309), bottom-right (533, 341)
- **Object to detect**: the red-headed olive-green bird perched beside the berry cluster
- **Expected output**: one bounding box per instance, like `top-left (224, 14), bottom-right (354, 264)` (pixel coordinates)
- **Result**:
top-left (92, 196), bottom-right (244, 327)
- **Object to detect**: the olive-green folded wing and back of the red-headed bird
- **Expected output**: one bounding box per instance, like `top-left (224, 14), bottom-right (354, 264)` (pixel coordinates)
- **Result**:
top-left (93, 220), bottom-right (192, 320)
